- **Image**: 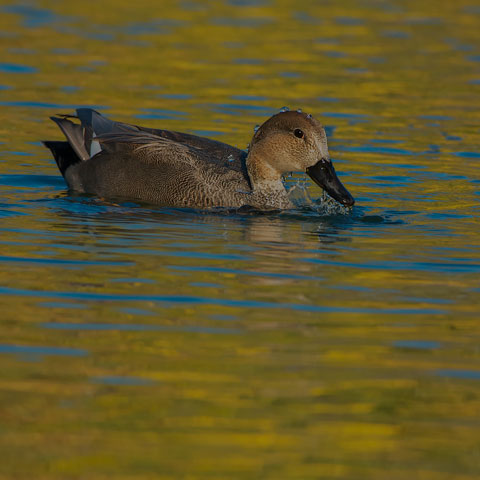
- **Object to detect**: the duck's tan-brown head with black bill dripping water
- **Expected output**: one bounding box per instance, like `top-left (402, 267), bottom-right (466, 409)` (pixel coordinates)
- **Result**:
top-left (247, 111), bottom-right (355, 207)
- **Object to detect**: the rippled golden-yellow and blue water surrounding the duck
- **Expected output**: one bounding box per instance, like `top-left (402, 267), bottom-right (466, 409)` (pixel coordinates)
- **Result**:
top-left (0, 0), bottom-right (480, 480)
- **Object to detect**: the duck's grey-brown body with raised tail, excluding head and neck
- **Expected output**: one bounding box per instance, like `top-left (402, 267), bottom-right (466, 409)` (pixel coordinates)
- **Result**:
top-left (46, 109), bottom-right (251, 207)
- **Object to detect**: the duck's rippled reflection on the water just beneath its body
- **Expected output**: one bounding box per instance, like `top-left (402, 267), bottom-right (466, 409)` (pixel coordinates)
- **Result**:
top-left (52, 197), bottom-right (355, 253)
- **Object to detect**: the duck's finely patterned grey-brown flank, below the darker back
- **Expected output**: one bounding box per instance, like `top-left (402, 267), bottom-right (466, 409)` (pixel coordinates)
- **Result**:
top-left (65, 123), bottom-right (251, 207)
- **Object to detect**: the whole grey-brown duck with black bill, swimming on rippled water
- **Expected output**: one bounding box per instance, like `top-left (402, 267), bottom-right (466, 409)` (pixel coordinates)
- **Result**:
top-left (43, 108), bottom-right (355, 210)
